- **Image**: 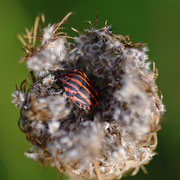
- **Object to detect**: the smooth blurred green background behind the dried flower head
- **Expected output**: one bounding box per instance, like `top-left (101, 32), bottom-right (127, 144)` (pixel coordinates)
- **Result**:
top-left (0, 0), bottom-right (180, 180)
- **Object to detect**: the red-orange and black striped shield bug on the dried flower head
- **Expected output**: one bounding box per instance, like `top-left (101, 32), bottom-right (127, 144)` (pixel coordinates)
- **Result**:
top-left (55, 69), bottom-right (98, 110)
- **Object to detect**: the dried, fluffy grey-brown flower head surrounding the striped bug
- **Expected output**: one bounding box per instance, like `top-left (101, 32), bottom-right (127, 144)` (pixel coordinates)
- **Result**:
top-left (12, 13), bottom-right (165, 180)
